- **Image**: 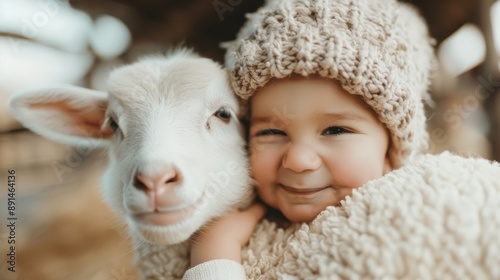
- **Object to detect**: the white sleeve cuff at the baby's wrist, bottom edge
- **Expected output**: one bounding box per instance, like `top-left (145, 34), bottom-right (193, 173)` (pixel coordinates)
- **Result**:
top-left (182, 259), bottom-right (247, 280)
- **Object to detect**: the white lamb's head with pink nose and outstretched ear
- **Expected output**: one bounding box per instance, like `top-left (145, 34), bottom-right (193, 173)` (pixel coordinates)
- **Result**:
top-left (10, 51), bottom-right (252, 244)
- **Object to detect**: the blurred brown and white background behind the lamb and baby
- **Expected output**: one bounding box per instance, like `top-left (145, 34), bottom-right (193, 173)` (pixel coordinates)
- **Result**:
top-left (0, 0), bottom-right (500, 280)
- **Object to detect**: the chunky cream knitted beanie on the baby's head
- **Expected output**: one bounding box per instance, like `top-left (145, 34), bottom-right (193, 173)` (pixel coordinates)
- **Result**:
top-left (223, 0), bottom-right (434, 168)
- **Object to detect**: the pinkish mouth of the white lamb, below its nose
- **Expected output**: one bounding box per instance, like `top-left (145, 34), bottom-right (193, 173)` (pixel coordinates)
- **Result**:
top-left (132, 195), bottom-right (204, 226)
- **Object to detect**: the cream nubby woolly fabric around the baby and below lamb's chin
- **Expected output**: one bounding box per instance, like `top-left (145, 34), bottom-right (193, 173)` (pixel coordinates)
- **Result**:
top-left (137, 152), bottom-right (500, 279)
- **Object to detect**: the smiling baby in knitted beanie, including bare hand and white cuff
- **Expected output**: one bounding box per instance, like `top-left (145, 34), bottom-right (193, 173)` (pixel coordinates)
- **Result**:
top-left (185, 0), bottom-right (433, 279)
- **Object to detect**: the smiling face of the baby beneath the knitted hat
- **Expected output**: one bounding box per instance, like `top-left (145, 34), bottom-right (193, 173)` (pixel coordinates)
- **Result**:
top-left (250, 78), bottom-right (390, 222)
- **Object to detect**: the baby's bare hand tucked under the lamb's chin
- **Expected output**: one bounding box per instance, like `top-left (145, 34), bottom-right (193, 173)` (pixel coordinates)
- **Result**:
top-left (191, 203), bottom-right (267, 267)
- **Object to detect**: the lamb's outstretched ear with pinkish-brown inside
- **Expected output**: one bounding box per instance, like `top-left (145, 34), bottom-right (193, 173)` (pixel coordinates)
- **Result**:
top-left (9, 85), bottom-right (113, 145)
